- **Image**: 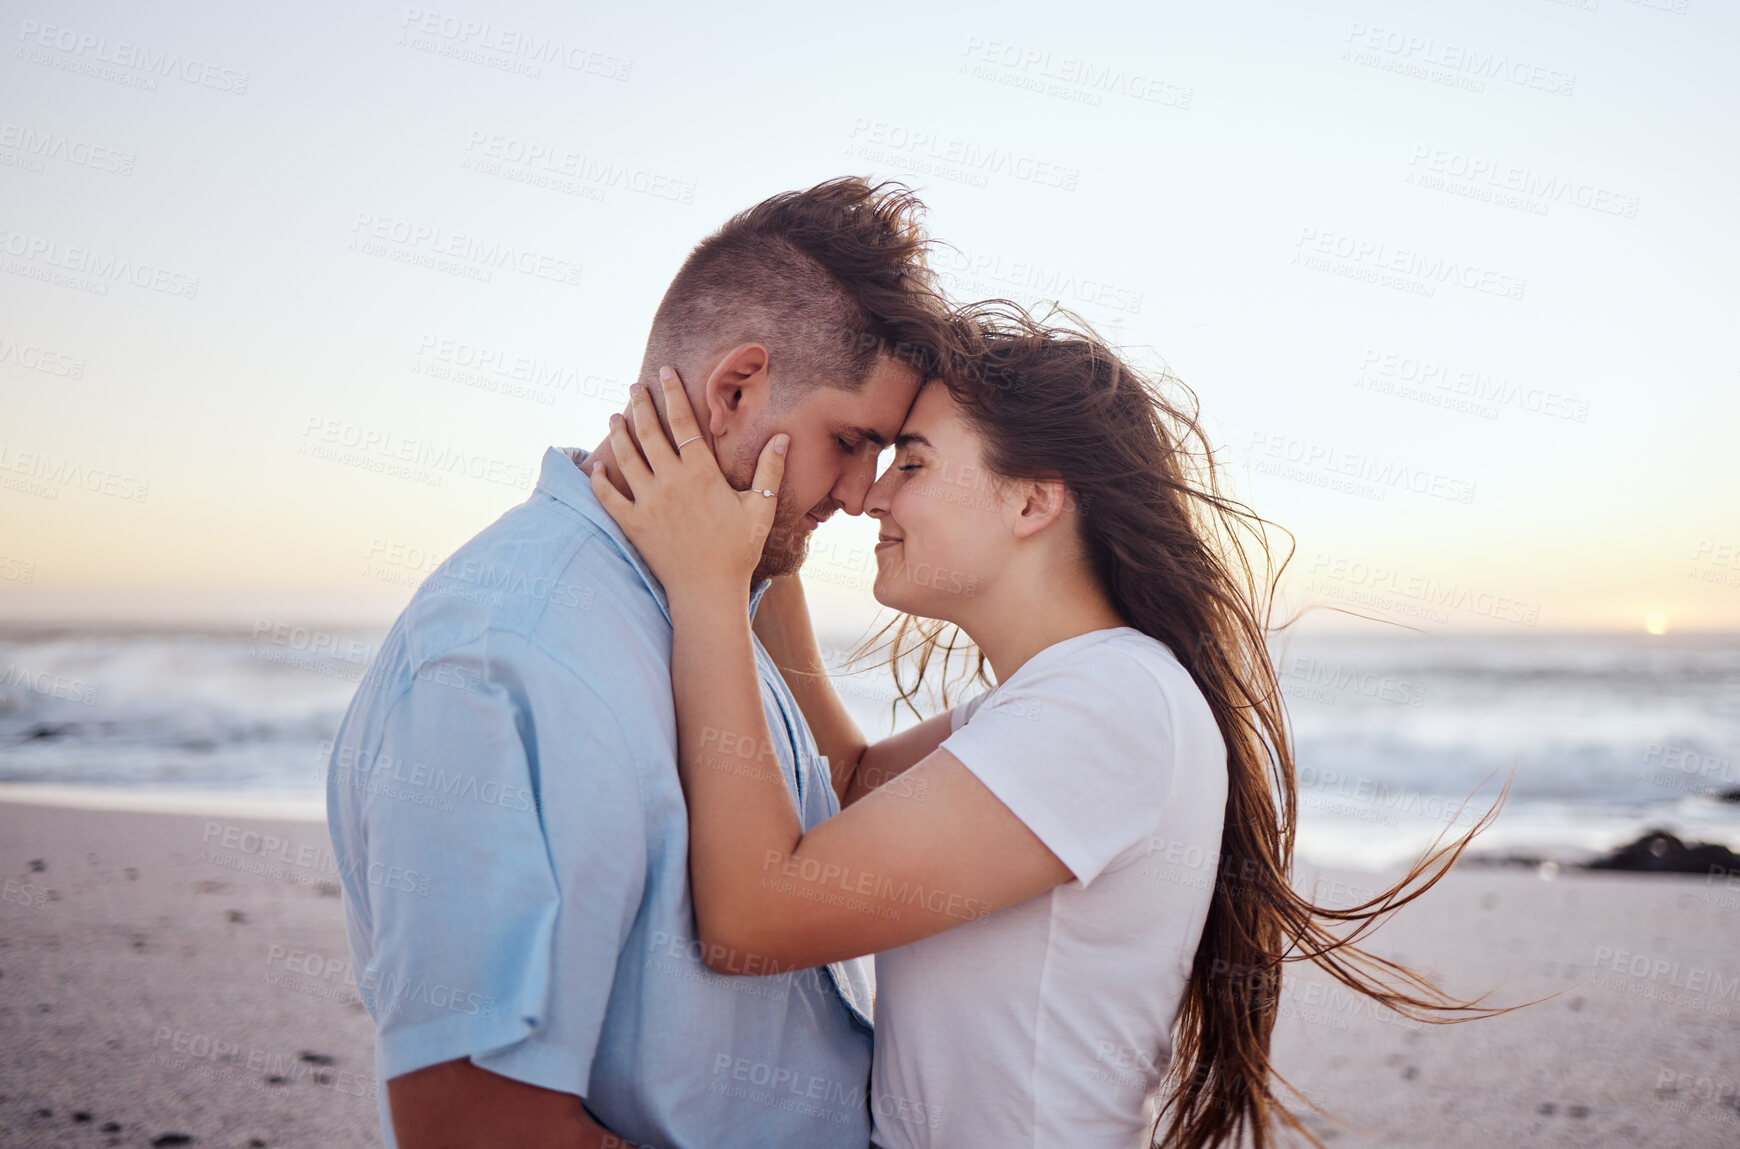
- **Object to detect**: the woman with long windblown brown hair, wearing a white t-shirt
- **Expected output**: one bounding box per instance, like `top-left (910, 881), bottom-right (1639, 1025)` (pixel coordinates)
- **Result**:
top-left (593, 310), bottom-right (1491, 1149)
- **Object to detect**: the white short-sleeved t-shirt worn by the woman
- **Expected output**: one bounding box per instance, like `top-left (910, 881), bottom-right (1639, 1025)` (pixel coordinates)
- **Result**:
top-left (872, 627), bottom-right (1227, 1149)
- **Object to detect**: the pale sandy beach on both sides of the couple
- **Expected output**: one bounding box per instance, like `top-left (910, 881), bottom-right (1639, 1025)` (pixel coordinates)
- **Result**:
top-left (0, 801), bottom-right (1740, 1147)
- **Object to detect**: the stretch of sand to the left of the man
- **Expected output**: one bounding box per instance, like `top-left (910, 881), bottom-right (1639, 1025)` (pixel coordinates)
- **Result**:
top-left (0, 803), bottom-right (381, 1147)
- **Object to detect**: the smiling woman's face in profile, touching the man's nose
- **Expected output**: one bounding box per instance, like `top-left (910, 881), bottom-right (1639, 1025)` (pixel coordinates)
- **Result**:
top-left (865, 383), bottom-right (1014, 622)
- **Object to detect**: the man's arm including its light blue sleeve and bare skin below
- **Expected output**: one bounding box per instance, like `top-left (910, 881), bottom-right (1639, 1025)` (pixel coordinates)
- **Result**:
top-left (349, 630), bottom-right (646, 1149)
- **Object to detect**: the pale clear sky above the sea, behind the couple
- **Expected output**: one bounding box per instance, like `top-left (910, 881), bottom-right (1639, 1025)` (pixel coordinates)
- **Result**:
top-left (0, 0), bottom-right (1740, 634)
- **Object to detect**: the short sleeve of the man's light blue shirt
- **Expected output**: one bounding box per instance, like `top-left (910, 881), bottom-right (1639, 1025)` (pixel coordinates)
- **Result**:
top-left (334, 637), bottom-right (646, 1095)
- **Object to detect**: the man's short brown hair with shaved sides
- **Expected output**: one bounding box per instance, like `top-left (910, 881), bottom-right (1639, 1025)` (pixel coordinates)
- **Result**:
top-left (640, 176), bottom-right (948, 396)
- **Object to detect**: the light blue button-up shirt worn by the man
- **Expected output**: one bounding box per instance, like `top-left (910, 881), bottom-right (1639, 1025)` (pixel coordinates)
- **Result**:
top-left (327, 447), bottom-right (872, 1149)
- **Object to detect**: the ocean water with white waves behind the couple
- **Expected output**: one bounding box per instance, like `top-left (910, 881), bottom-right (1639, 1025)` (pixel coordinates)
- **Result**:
top-left (0, 623), bottom-right (1740, 867)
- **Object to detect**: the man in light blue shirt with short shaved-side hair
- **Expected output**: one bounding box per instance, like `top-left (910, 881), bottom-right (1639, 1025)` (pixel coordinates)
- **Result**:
top-left (327, 179), bottom-right (945, 1149)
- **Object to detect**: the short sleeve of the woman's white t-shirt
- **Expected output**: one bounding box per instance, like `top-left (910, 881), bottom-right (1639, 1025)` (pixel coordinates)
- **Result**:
top-left (941, 641), bottom-right (1176, 886)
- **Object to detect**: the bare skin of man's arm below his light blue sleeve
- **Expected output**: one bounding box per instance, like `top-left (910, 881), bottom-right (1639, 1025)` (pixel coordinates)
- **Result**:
top-left (386, 1057), bottom-right (628, 1149)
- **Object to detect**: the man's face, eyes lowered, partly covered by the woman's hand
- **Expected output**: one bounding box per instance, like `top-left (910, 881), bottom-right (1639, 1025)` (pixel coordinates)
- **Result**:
top-left (719, 359), bottom-right (922, 580)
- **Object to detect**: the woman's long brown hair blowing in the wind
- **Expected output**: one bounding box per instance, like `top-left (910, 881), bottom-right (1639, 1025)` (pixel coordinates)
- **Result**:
top-left (860, 301), bottom-right (1509, 1149)
